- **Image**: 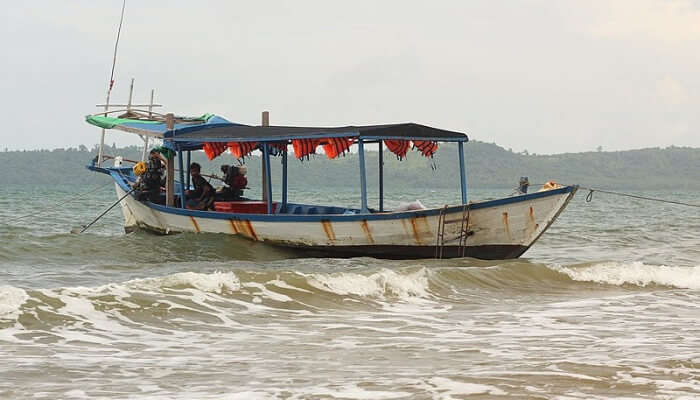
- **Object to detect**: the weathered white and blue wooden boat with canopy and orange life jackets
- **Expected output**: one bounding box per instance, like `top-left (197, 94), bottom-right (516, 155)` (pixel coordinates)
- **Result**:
top-left (86, 109), bottom-right (577, 259)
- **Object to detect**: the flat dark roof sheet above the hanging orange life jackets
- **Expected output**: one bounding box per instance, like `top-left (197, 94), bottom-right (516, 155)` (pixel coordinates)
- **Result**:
top-left (164, 123), bottom-right (469, 143)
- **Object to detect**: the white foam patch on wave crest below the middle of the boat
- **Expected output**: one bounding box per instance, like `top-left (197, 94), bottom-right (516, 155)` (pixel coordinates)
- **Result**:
top-left (308, 268), bottom-right (430, 300)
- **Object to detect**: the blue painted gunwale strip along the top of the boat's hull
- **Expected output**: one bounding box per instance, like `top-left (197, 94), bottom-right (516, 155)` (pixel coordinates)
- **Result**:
top-left (94, 166), bottom-right (578, 222)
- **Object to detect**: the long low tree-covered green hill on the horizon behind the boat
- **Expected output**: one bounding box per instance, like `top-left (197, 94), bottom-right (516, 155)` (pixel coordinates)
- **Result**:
top-left (0, 141), bottom-right (700, 189)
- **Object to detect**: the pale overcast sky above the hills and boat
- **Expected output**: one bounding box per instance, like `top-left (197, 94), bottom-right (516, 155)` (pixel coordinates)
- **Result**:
top-left (0, 0), bottom-right (700, 154)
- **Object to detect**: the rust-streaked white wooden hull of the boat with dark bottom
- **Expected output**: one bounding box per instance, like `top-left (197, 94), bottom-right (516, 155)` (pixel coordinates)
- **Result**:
top-left (115, 177), bottom-right (577, 259)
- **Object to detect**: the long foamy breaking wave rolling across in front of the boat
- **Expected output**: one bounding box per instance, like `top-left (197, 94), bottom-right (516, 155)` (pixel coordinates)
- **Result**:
top-left (0, 260), bottom-right (700, 327)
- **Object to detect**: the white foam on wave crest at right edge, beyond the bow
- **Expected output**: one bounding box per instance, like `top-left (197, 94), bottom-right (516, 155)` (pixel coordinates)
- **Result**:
top-left (552, 262), bottom-right (700, 289)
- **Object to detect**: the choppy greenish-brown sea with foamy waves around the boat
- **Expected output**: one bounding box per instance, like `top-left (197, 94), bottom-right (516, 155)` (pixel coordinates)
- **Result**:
top-left (0, 177), bottom-right (700, 399)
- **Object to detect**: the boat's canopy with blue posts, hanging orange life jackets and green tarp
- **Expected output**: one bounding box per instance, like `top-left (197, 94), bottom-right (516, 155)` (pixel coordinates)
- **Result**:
top-left (86, 109), bottom-right (469, 214)
